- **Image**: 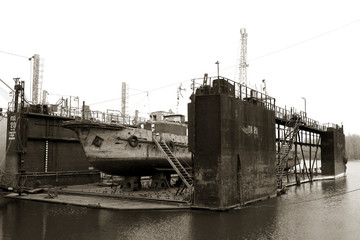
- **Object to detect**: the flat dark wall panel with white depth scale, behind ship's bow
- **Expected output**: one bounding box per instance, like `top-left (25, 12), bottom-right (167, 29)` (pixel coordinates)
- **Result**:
top-left (24, 115), bottom-right (91, 172)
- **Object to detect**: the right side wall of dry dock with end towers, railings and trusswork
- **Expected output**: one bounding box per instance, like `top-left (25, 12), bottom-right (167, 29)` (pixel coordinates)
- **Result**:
top-left (188, 74), bottom-right (346, 210)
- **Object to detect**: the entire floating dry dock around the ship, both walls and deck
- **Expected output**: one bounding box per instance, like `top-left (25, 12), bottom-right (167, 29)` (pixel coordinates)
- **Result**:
top-left (1, 75), bottom-right (346, 210)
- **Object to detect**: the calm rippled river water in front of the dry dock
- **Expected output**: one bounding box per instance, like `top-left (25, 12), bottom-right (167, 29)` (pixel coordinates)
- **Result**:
top-left (0, 161), bottom-right (360, 240)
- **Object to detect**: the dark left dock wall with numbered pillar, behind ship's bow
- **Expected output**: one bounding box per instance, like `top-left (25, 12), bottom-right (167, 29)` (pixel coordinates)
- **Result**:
top-left (0, 113), bottom-right (100, 188)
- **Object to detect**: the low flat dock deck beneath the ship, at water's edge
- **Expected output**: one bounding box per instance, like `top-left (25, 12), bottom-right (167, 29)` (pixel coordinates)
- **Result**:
top-left (6, 184), bottom-right (191, 211)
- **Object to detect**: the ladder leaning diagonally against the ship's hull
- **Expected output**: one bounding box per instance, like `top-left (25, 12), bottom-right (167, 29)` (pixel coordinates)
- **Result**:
top-left (153, 137), bottom-right (194, 189)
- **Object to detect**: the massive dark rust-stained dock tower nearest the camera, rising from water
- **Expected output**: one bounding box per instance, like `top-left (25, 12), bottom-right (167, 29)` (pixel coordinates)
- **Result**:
top-left (188, 91), bottom-right (276, 209)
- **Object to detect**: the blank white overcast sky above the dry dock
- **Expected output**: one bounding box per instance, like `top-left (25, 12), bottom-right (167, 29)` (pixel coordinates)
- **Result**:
top-left (0, 0), bottom-right (360, 134)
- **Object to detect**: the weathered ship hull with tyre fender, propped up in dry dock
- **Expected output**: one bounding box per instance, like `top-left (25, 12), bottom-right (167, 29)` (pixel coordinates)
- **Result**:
top-left (64, 120), bottom-right (191, 176)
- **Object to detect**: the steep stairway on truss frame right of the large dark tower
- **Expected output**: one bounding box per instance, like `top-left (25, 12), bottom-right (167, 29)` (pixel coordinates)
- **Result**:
top-left (276, 115), bottom-right (301, 189)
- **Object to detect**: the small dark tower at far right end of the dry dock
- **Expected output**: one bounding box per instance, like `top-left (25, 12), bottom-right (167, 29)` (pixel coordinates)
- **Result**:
top-left (321, 127), bottom-right (346, 176)
